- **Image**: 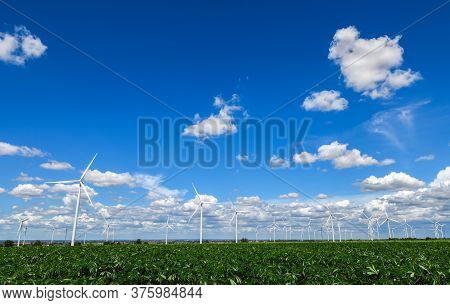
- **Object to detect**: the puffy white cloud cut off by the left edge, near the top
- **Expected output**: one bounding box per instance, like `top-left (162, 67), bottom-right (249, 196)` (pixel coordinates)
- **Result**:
top-left (0, 26), bottom-right (47, 65)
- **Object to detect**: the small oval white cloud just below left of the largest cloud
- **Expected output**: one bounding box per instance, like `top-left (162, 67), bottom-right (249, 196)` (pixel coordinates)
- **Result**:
top-left (302, 90), bottom-right (348, 112)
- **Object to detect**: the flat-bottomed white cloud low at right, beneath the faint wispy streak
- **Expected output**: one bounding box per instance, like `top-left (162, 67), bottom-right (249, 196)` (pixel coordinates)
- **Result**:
top-left (361, 172), bottom-right (425, 191)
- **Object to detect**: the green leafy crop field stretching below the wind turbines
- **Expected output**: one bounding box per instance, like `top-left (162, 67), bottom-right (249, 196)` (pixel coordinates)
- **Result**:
top-left (0, 241), bottom-right (450, 285)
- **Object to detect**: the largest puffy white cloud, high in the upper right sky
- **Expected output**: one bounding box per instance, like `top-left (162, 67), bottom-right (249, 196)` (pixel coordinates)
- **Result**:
top-left (328, 26), bottom-right (421, 99)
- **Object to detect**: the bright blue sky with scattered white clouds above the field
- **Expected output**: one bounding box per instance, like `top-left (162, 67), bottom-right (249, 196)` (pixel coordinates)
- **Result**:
top-left (0, 0), bottom-right (450, 240)
